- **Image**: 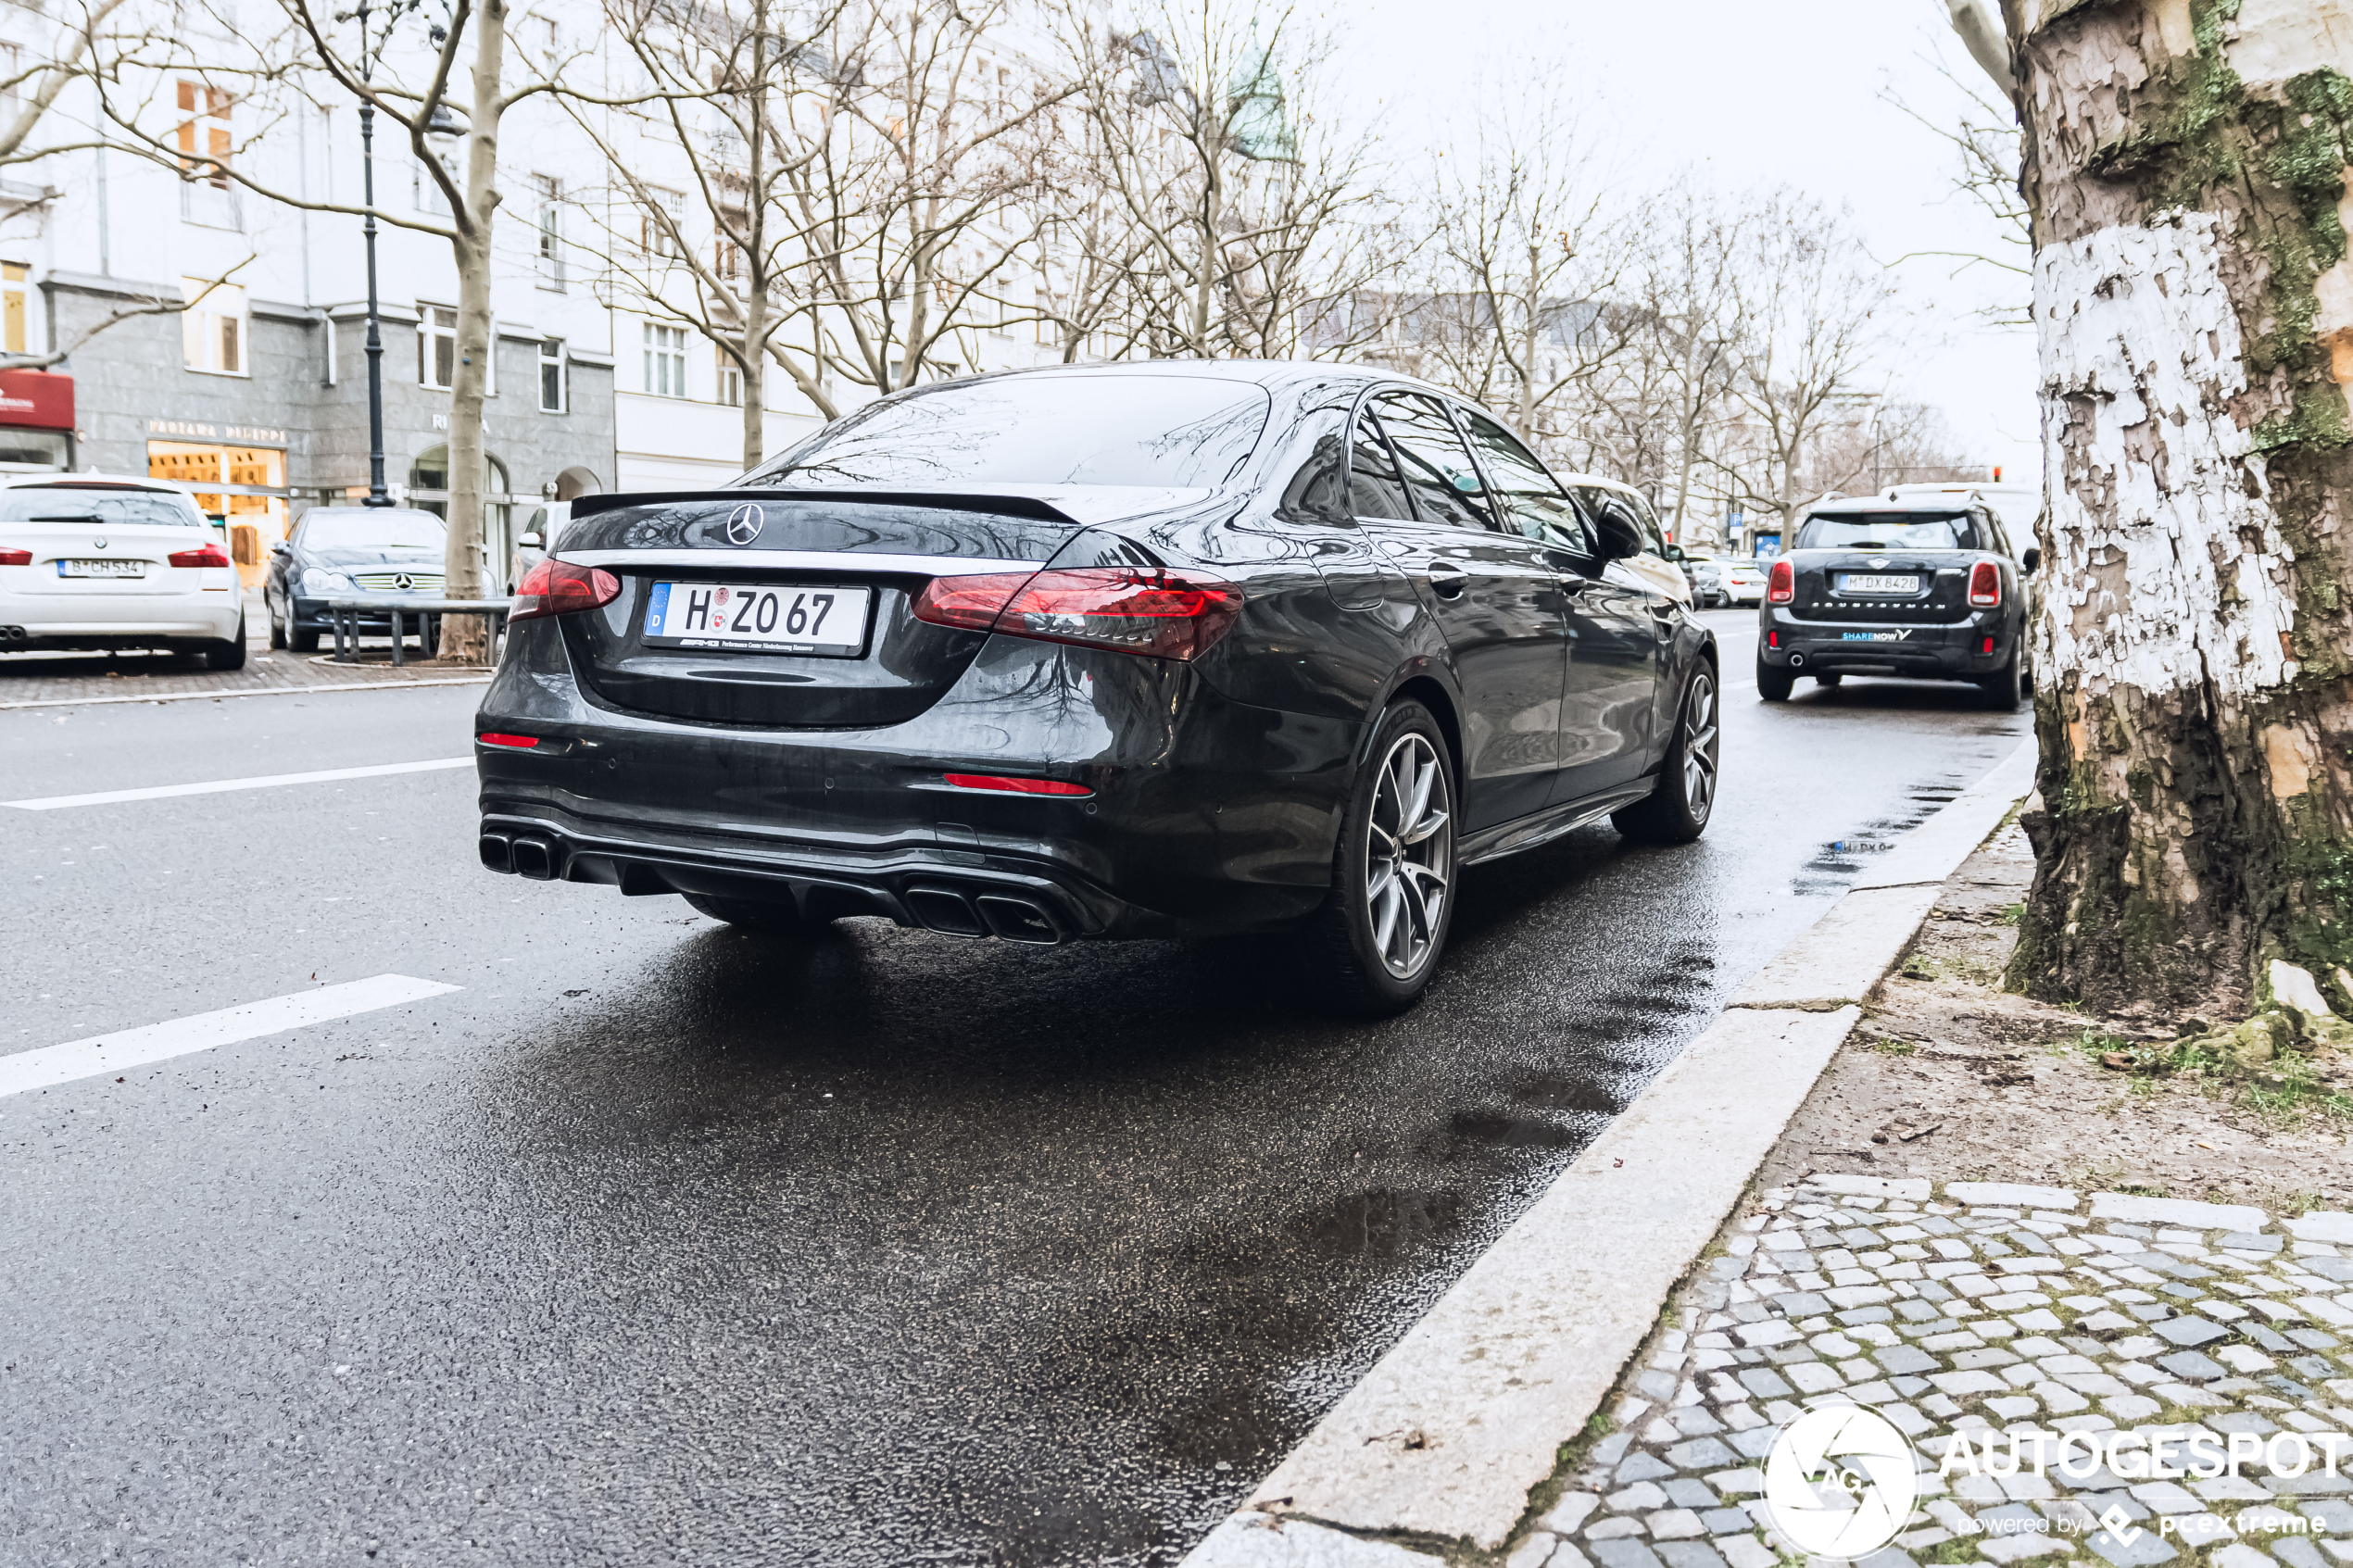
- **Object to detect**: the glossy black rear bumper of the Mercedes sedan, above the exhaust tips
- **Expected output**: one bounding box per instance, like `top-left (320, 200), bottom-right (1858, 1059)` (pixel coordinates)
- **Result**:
top-left (478, 623), bottom-right (1360, 940)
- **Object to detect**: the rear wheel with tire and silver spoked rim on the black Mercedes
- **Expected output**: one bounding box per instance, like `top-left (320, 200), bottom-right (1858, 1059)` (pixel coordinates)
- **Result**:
top-left (1299, 700), bottom-right (1456, 1018)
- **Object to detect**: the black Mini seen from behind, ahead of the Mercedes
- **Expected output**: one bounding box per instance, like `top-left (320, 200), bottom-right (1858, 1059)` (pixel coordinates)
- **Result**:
top-left (1757, 494), bottom-right (2043, 710)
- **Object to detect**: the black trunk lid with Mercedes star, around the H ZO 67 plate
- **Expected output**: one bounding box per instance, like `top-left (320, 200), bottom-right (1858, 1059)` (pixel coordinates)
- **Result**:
top-left (555, 491), bottom-right (1080, 729)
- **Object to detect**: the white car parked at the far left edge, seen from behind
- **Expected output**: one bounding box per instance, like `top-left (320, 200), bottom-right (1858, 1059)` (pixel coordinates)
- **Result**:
top-left (0, 472), bottom-right (245, 670)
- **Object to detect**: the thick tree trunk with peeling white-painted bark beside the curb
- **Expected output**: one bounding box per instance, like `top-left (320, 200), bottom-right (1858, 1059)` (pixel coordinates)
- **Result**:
top-left (2005, 0), bottom-right (2353, 1010)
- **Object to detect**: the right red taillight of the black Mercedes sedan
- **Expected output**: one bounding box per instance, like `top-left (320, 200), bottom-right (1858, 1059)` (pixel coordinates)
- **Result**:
top-left (915, 567), bottom-right (1242, 659)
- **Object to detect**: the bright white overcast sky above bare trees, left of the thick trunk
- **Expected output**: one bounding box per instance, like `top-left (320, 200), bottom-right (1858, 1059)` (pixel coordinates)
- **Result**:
top-left (1306, 0), bottom-right (2043, 484)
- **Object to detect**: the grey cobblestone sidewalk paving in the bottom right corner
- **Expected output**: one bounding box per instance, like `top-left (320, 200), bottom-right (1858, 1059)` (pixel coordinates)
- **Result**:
top-left (1506, 1175), bottom-right (2353, 1568)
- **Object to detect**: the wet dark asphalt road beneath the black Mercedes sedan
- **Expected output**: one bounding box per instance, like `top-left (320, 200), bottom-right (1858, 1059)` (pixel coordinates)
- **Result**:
top-left (0, 611), bottom-right (2028, 1565)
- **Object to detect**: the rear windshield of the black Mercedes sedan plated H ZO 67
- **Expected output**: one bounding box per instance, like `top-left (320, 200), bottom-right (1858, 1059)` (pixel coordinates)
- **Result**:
top-left (739, 376), bottom-right (1273, 489)
